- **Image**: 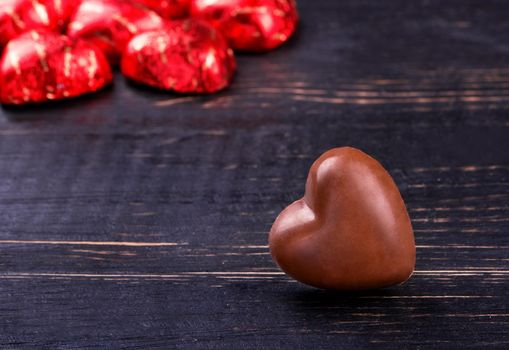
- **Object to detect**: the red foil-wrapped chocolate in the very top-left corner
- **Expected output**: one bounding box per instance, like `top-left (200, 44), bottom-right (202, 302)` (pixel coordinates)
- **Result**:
top-left (0, 0), bottom-right (59, 48)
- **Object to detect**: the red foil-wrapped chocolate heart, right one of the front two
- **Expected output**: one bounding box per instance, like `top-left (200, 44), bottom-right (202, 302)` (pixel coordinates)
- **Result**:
top-left (121, 19), bottom-right (236, 93)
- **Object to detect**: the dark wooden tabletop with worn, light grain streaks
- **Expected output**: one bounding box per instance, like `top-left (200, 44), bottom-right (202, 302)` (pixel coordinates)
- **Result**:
top-left (0, 0), bottom-right (509, 349)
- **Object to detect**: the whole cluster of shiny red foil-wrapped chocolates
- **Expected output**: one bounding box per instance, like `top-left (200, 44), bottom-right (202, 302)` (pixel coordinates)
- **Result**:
top-left (0, 0), bottom-right (298, 104)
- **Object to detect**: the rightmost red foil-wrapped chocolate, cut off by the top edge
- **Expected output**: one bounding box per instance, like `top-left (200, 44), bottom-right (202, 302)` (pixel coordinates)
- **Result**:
top-left (191, 0), bottom-right (298, 52)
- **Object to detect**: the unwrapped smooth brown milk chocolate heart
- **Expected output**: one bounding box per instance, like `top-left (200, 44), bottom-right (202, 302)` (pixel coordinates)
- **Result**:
top-left (269, 147), bottom-right (415, 290)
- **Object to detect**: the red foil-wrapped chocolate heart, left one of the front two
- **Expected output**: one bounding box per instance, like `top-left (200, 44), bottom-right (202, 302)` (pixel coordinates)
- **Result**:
top-left (0, 31), bottom-right (112, 104)
